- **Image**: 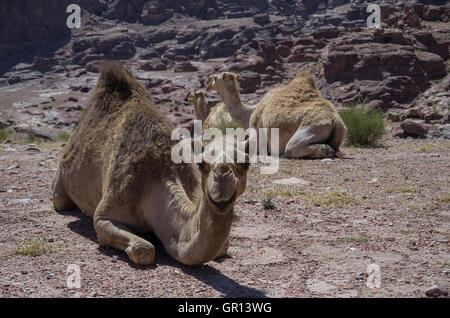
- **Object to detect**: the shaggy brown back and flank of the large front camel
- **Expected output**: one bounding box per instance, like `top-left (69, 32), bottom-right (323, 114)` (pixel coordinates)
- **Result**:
top-left (60, 62), bottom-right (179, 214)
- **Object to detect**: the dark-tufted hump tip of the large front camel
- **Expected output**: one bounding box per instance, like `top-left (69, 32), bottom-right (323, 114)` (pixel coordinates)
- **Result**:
top-left (97, 61), bottom-right (136, 97)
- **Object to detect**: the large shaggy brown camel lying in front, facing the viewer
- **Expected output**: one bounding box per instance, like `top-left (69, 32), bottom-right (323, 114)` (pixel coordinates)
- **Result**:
top-left (53, 62), bottom-right (249, 265)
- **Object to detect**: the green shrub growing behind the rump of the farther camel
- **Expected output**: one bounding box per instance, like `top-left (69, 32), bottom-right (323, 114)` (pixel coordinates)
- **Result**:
top-left (340, 105), bottom-right (386, 147)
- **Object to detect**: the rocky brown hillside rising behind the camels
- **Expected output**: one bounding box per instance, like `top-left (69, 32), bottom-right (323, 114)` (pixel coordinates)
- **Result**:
top-left (0, 0), bottom-right (450, 139)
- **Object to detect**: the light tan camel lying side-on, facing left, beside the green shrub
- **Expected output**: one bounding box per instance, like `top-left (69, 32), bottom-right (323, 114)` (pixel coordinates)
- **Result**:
top-left (207, 72), bottom-right (347, 159)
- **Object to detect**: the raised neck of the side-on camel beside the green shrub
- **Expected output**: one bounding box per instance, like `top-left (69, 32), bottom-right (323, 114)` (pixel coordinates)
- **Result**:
top-left (219, 89), bottom-right (256, 129)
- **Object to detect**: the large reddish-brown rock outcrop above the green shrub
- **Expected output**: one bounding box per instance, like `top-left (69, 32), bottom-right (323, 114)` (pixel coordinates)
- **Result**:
top-left (323, 31), bottom-right (446, 109)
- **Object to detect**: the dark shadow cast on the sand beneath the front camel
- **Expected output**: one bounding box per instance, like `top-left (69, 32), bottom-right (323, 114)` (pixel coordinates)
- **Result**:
top-left (57, 209), bottom-right (266, 298)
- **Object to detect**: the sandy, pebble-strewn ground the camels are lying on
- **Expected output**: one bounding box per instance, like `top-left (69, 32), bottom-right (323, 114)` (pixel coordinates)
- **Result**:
top-left (0, 139), bottom-right (450, 297)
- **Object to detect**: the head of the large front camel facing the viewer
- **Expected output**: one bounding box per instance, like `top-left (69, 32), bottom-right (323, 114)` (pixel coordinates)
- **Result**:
top-left (199, 135), bottom-right (250, 215)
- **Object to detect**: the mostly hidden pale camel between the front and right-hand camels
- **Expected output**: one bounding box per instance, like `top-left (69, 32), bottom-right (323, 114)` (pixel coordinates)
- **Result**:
top-left (189, 91), bottom-right (239, 133)
